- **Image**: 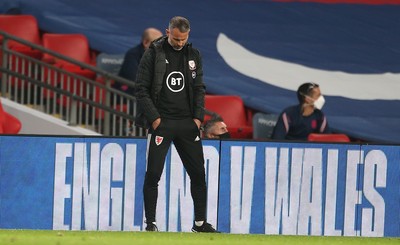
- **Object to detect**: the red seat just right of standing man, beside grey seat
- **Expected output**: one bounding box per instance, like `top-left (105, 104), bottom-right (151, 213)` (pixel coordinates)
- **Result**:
top-left (204, 95), bottom-right (253, 139)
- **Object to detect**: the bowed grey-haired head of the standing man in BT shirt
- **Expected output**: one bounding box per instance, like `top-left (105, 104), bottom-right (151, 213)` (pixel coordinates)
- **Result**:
top-left (165, 16), bottom-right (190, 50)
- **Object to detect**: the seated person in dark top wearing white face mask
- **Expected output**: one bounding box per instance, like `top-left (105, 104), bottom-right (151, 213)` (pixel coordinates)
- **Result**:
top-left (272, 83), bottom-right (331, 140)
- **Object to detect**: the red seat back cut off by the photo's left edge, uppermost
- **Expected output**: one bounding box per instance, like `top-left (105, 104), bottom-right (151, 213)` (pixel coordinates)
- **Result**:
top-left (0, 15), bottom-right (41, 49)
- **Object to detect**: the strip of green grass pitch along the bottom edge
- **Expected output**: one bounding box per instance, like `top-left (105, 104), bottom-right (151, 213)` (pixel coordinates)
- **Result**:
top-left (0, 230), bottom-right (400, 245)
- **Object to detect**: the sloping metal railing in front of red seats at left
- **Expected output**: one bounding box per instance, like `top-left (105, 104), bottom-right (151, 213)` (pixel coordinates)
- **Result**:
top-left (0, 31), bottom-right (145, 136)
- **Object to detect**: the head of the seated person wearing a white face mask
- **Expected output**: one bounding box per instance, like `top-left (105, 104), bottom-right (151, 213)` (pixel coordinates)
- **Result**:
top-left (297, 83), bottom-right (325, 110)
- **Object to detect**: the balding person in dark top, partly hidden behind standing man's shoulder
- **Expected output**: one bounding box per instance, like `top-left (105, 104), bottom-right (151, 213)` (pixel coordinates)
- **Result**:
top-left (113, 27), bottom-right (163, 95)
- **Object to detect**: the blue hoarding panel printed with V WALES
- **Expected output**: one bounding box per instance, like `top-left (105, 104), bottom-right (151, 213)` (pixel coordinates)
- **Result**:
top-left (218, 142), bottom-right (400, 236)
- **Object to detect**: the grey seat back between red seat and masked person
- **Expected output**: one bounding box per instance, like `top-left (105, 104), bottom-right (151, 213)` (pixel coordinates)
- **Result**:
top-left (253, 112), bottom-right (279, 139)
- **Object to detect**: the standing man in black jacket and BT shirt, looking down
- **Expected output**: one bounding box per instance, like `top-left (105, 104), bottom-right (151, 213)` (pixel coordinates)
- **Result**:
top-left (135, 16), bottom-right (217, 232)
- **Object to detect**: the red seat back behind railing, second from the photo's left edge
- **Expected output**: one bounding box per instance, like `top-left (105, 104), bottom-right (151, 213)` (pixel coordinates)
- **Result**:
top-left (43, 33), bottom-right (91, 66)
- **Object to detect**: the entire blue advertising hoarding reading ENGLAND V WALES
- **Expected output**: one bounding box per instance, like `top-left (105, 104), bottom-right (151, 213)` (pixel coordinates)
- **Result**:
top-left (0, 136), bottom-right (400, 237)
